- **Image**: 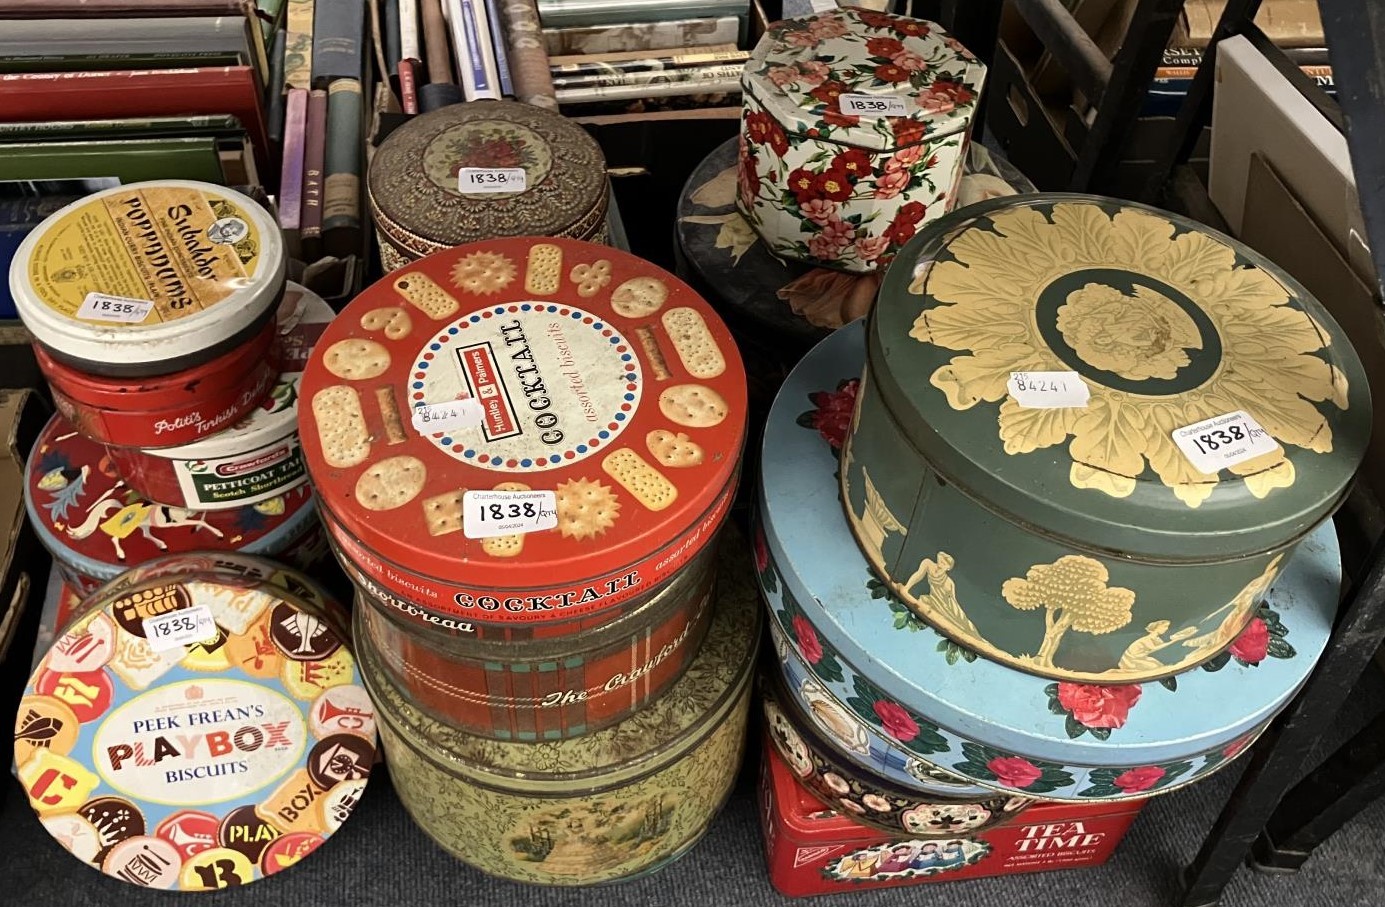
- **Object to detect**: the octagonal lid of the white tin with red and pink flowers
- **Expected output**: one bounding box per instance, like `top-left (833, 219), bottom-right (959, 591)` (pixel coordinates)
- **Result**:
top-left (741, 8), bottom-right (986, 151)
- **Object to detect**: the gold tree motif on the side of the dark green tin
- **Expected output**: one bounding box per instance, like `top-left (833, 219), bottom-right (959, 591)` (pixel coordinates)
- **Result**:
top-left (1000, 554), bottom-right (1134, 667)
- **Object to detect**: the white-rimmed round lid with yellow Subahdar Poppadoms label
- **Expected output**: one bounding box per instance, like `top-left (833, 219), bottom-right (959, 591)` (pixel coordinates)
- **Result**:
top-left (10, 180), bottom-right (287, 375)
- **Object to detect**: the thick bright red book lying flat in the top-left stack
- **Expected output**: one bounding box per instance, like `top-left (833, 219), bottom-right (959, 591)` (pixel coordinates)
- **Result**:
top-left (0, 66), bottom-right (273, 173)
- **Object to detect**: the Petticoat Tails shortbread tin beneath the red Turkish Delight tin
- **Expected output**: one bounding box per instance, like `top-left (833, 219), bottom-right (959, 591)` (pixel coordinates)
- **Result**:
top-left (109, 282), bottom-right (334, 510)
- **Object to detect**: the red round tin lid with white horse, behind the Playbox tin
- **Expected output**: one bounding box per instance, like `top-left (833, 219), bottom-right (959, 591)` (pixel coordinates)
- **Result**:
top-left (24, 415), bottom-right (317, 582)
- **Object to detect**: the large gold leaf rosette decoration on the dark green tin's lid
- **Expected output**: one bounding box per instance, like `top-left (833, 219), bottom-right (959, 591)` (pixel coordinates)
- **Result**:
top-left (910, 202), bottom-right (1348, 507)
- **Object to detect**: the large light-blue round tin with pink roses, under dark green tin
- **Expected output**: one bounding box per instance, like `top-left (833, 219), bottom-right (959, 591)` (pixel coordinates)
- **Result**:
top-left (758, 323), bottom-right (1342, 800)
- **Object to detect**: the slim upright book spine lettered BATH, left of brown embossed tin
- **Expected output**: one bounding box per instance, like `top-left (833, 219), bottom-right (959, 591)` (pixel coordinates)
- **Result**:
top-left (323, 79), bottom-right (364, 258)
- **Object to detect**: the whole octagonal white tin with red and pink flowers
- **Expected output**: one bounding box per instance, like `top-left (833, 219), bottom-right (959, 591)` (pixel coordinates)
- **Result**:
top-left (738, 8), bottom-right (986, 271)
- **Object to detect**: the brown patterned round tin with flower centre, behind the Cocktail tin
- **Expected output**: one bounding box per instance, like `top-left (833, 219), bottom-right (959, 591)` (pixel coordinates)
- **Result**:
top-left (366, 100), bottom-right (609, 271)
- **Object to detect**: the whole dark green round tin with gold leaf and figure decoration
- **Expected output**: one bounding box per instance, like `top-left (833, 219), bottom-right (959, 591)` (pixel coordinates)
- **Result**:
top-left (841, 195), bottom-right (1371, 684)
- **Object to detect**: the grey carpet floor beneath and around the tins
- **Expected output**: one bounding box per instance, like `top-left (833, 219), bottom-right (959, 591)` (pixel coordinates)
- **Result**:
top-left (0, 736), bottom-right (1385, 907)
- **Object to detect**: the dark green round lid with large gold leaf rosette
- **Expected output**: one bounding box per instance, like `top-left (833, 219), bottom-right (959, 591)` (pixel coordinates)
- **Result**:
top-left (867, 194), bottom-right (1371, 559)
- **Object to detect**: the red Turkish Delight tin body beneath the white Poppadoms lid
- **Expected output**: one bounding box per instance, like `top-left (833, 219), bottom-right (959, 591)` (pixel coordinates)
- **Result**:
top-left (33, 318), bottom-right (278, 447)
